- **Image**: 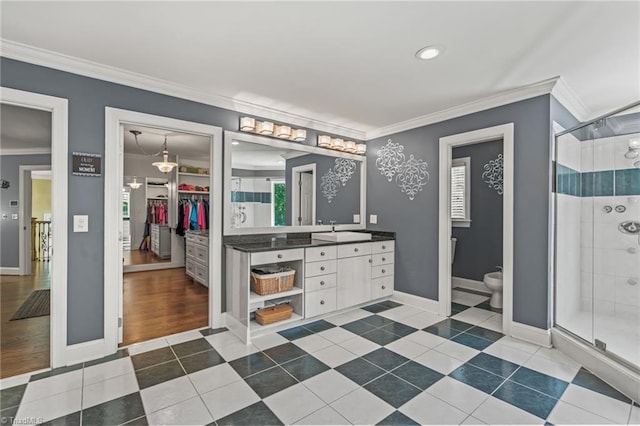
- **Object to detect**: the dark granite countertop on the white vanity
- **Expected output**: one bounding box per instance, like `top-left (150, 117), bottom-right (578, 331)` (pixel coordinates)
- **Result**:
top-left (224, 231), bottom-right (395, 253)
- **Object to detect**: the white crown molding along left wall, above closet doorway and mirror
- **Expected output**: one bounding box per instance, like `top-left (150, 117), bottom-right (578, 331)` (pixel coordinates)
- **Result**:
top-left (0, 38), bottom-right (365, 140)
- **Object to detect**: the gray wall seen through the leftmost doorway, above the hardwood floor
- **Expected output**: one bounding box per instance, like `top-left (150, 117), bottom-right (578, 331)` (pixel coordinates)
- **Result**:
top-left (0, 154), bottom-right (51, 268)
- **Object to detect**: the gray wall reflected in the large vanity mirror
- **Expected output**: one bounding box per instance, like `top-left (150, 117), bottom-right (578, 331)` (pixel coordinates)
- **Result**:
top-left (285, 154), bottom-right (362, 225)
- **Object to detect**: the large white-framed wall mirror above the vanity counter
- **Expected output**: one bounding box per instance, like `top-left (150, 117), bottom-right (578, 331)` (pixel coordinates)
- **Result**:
top-left (223, 132), bottom-right (366, 235)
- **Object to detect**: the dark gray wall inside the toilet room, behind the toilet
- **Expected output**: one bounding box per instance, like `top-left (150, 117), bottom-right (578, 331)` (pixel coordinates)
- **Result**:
top-left (451, 140), bottom-right (502, 281)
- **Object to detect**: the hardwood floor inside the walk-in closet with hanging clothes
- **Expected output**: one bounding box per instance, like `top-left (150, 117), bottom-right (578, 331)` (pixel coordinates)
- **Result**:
top-left (120, 268), bottom-right (209, 346)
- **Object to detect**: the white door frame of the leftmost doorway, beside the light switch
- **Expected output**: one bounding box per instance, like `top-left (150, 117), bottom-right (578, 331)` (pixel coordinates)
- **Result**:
top-left (0, 87), bottom-right (71, 368)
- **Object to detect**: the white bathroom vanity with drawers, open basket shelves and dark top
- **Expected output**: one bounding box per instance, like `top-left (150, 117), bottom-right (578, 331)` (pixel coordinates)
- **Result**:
top-left (226, 233), bottom-right (395, 343)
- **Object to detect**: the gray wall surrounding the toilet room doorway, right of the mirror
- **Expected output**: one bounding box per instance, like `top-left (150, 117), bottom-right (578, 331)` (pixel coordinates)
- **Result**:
top-left (367, 95), bottom-right (551, 328)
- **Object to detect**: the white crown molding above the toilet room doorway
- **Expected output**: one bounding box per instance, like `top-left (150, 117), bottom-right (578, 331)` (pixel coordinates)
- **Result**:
top-left (366, 77), bottom-right (559, 140)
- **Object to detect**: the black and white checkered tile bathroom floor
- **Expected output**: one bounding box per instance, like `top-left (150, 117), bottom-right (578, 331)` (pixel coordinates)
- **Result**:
top-left (1, 302), bottom-right (640, 425)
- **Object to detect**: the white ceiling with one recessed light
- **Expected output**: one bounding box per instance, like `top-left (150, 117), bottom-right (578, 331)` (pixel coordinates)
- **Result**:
top-left (0, 1), bottom-right (640, 132)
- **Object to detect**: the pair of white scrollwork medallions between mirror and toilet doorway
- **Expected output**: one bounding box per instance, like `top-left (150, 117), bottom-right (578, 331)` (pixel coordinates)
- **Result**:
top-left (376, 139), bottom-right (429, 201)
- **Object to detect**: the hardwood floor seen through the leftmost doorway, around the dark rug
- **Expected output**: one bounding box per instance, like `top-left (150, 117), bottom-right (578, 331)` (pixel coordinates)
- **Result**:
top-left (0, 262), bottom-right (51, 378)
